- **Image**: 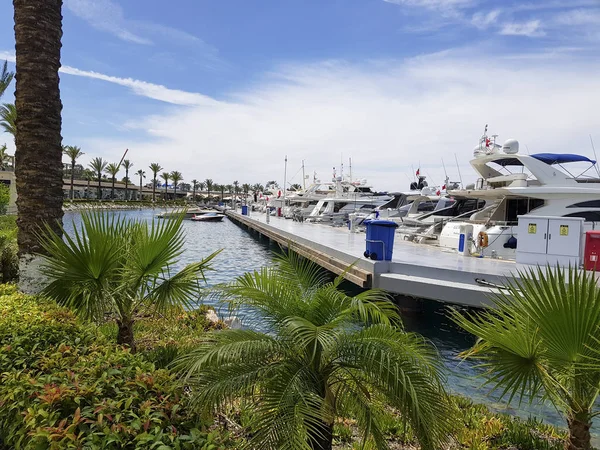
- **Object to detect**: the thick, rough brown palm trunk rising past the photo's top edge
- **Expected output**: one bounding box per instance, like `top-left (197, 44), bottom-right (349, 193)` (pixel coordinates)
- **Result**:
top-left (13, 0), bottom-right (63, 256)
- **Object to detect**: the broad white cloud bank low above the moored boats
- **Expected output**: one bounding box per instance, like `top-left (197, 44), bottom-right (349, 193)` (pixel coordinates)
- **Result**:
top-left (65, 49), bottom-right (600, 190)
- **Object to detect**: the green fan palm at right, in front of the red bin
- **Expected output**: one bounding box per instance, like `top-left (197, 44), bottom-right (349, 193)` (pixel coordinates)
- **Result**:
top-left (453, 267), bottom-right (600, 450)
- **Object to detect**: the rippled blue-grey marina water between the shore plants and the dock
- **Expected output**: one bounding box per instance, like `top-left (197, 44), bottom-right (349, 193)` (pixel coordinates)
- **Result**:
top-left (64, 210), bottom-right (576, 445)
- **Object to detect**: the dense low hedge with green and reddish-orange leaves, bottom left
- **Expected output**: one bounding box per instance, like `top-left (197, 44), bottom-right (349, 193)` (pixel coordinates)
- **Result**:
top-left (0, 285), bottom-right (229, 449)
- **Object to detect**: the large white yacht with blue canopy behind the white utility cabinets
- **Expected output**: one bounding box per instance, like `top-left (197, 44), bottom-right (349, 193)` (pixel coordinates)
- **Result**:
top-left (439, 127), bottom-right (600, 259)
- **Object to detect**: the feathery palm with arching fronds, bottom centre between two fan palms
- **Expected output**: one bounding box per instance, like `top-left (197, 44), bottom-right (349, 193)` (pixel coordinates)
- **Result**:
top-left (176, 252), bottom-right (449, 450)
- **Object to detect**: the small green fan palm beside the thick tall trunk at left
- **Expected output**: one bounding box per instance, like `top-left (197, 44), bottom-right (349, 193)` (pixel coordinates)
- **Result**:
top-left (42, 212), bottom-right (218, 351)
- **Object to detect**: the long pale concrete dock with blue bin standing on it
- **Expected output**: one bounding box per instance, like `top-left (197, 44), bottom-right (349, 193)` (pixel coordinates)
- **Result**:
top-left (226, 211), bottom-right (517, 307)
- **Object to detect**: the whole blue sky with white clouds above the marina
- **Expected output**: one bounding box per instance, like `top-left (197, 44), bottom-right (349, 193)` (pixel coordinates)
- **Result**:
top-left (0, 0), bottom-right (600, 191)
